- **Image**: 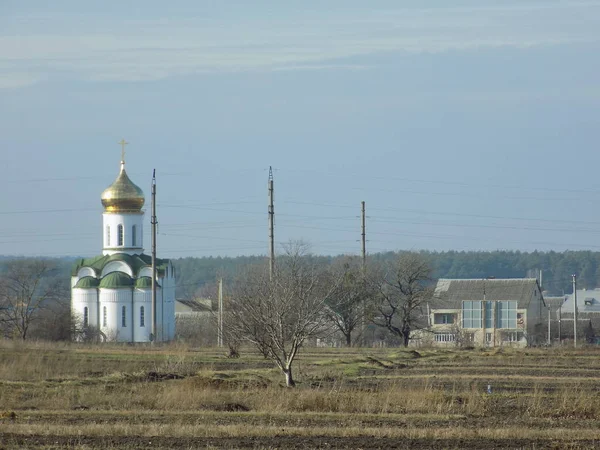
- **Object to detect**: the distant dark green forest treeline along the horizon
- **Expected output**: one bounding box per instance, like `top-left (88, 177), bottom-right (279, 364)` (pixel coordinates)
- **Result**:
top-left (0, 251), bottom-right (600, 298)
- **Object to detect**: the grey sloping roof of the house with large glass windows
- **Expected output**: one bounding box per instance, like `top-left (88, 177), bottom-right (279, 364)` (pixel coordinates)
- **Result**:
top-left (432, 278), bottom-right (544, 308)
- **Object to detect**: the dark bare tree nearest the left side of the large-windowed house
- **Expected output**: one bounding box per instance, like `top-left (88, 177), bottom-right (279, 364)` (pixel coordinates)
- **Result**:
top-left (371, 253), bottom-right (432, 347)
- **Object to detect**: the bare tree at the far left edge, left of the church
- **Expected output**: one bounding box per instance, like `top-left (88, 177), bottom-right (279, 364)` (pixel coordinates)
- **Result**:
top-left (0, 259), bottom-right (61, 340)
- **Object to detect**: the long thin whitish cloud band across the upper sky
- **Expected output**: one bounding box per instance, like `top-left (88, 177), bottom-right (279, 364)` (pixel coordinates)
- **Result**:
top-left (0, 2), bottom-right (600, 88)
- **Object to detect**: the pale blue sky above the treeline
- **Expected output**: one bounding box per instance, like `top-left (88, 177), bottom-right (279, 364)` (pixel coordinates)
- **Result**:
top-left (0, 0), bottom-right (600, 258)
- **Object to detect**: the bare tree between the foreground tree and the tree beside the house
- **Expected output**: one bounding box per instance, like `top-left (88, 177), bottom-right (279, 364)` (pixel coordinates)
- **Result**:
top-left (324, 257), bottom-right (372, 347)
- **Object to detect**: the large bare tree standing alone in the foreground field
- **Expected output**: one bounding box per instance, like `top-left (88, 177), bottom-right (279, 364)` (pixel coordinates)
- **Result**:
top-left (228, 243), bottom-right (329, 387)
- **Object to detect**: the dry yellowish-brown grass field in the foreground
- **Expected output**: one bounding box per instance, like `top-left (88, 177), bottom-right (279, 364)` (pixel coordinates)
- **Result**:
top-left (0, 341), bottom-right (600, 449)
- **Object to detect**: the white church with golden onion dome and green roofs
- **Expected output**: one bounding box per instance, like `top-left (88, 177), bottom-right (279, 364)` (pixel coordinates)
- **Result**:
top-left (71, 148), bottom-right (175, 342)
